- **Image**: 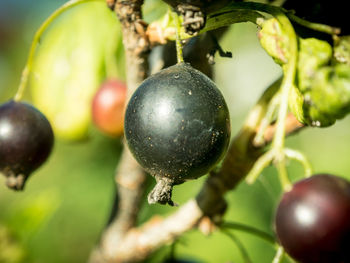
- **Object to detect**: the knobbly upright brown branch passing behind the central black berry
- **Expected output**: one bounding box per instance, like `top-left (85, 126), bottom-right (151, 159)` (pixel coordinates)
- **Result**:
top-left (90, 0), bottom-right (150, 262)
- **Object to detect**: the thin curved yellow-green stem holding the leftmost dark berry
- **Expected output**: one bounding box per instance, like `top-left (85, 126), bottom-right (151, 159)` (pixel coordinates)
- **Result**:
top-left (14, 0), bottom-right (104, 101)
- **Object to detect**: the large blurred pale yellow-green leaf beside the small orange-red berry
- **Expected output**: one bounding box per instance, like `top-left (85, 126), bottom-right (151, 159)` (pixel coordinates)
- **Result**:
top-left (30, 2), bottom-right (121, 140)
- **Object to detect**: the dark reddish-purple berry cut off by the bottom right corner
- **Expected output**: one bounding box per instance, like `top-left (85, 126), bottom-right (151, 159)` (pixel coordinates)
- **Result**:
top-left (276, 174), bottom-right (350, 263)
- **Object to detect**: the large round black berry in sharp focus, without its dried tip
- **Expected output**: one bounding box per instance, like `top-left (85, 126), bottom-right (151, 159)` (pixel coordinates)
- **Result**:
top-left (124, 63), bottom-right (230, 205)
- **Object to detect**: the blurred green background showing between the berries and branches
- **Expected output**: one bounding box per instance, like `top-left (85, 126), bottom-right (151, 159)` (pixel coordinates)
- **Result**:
top-left (0, 0), bottom-right (350, 263)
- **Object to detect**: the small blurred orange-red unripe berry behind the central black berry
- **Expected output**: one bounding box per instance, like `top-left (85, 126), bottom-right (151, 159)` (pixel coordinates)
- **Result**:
top-left (92, 79), bottom-right (127, 137)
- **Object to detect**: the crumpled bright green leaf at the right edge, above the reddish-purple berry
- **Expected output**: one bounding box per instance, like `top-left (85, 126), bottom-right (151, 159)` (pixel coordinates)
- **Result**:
top-left (290, 38), bottom-right (350, 127)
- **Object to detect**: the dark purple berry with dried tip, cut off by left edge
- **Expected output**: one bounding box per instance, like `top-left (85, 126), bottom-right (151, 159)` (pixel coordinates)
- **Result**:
top-left (0, 101), bottom-right (54, 190)
